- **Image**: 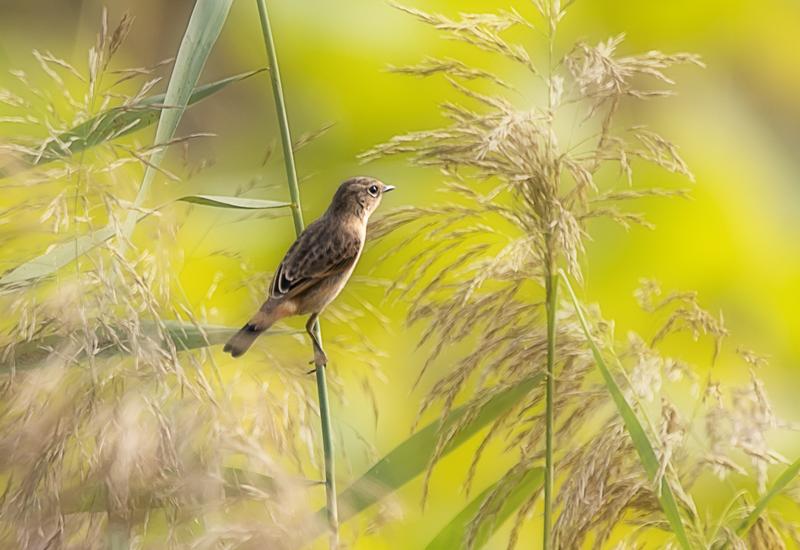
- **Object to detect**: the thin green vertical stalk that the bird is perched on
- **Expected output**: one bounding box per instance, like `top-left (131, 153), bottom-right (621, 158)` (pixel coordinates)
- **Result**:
top-left (256, 0), bottom-right (339, 548)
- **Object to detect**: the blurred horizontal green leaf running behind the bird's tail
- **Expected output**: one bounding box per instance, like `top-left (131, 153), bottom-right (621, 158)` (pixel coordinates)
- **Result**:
top-left (0, 321), bottom-right (298, 373)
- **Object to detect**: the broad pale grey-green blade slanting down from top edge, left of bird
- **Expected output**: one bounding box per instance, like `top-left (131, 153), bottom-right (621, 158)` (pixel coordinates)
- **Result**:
top-left (123, 0), bottom-right (233, 237)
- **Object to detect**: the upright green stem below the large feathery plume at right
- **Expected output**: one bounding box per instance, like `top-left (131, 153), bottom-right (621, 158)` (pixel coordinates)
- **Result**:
top-left (542, 269), bottom-right (558, 550)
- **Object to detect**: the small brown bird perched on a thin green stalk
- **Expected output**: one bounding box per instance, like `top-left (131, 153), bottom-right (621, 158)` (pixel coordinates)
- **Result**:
top-left (223, 177), bottom-right (394, 365)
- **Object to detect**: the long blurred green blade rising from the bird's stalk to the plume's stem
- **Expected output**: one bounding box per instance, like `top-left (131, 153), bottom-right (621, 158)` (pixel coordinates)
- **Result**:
top-left (310, 374), bottom-right (544, 538)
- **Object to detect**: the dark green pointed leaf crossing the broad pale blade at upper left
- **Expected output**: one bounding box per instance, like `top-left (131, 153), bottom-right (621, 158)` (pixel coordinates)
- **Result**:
top-left (21, 69), bottom-right (264, 170)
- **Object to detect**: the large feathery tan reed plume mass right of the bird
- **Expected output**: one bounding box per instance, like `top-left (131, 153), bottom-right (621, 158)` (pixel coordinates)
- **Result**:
top-left (362, 0), bottom-right (796, 548)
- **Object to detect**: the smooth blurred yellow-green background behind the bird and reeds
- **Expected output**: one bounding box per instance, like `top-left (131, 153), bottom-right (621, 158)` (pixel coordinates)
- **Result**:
top-left (0, 0), bottom-right (800, 549)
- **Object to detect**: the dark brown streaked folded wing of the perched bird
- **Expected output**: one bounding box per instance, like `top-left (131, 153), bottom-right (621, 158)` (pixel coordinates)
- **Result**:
top-left (270, 220), bottom-right (361, 298)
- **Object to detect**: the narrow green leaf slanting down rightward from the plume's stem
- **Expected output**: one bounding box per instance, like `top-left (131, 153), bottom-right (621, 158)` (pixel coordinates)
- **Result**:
top-left (561, 270), bottom-right (691, 550)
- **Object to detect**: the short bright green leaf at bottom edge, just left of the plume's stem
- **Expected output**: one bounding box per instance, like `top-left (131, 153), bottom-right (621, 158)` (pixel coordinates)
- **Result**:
top-left (425, 468), bottom-right (544, 550)
